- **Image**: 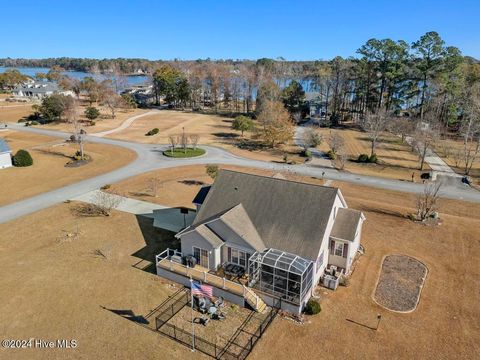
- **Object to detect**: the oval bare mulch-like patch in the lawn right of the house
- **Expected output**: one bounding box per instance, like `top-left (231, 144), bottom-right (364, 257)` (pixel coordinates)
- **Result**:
top-left (373, 255), bottom-right (428, 312)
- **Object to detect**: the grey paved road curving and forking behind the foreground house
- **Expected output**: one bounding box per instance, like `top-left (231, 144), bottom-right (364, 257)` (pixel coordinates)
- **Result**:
top-left (0, 124), bottom-right (480, 223)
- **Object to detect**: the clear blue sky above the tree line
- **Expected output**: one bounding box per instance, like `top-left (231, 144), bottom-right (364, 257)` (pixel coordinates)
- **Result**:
top-left (0, 0), bottom-right (480, 60)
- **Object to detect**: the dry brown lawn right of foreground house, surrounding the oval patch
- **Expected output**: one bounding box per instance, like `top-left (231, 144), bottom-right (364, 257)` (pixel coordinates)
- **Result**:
top-left (251, 183), bottom-right (480, 360)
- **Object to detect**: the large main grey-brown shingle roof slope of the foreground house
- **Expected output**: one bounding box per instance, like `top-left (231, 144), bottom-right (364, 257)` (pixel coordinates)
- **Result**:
top-left (192, 170), bottom-right (338, 260)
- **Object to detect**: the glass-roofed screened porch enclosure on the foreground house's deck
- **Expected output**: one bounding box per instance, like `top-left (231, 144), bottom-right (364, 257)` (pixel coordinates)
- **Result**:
top-left (248, 249), bottom-right (313, 305)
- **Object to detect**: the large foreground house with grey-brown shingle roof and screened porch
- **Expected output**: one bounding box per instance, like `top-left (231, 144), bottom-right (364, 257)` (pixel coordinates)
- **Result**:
top-left (157, 170), bottom-right (365, 313)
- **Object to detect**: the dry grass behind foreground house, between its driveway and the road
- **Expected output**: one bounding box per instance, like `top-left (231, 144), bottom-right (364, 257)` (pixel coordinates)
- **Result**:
top-left (109, 165), bottom-right (323, 208)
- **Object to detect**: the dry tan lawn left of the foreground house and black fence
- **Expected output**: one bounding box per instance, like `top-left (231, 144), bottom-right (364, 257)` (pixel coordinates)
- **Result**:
top-left (0, 203), bottom-right (202, 359)
